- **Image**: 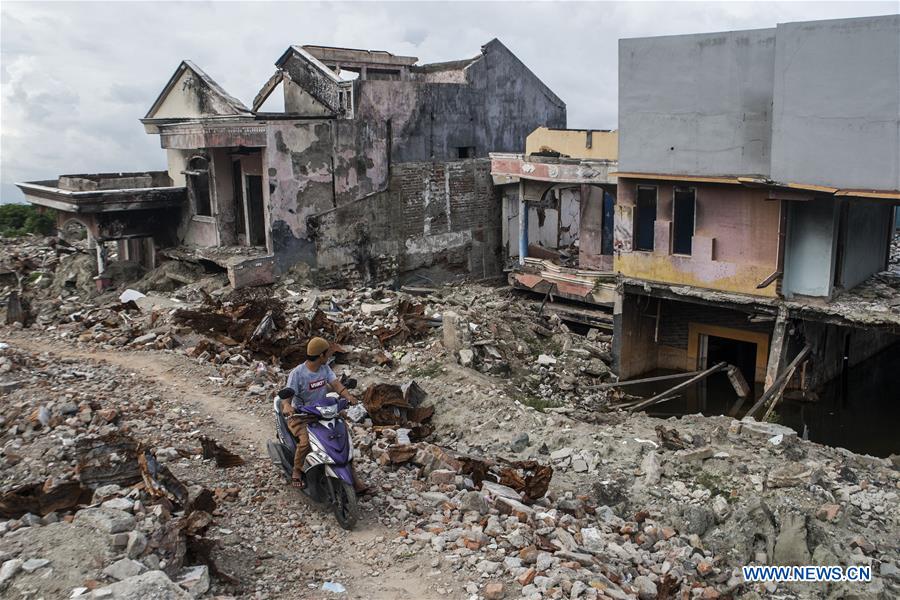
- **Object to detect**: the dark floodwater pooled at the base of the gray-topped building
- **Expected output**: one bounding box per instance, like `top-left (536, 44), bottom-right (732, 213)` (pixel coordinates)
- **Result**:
top-left (623, 344), bottom-right (900, 456)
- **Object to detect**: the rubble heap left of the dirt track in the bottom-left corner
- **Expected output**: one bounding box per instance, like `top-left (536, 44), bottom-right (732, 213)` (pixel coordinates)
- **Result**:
top-left (0, 347), bottom-right (241, 598)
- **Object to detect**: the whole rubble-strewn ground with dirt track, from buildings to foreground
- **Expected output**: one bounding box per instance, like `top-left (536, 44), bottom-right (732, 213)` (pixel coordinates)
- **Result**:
top-left (0, 236), bottom-right (900, 599)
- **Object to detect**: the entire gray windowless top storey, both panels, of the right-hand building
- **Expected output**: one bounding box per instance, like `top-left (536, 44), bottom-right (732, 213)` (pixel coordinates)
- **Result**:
top-left (619, 15), bottom-right (900, 190)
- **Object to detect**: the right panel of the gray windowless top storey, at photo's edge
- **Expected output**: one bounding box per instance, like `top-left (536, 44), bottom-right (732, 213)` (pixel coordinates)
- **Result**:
top-left (772, 15), bottom-right (900, 190)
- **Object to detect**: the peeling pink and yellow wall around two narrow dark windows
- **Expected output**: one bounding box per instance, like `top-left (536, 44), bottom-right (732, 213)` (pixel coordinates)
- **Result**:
top-left (614, 179), bottom-right (780, 297)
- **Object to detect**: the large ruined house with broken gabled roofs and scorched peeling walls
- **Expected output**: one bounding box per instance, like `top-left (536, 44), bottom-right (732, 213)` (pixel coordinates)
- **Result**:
top-left (19, 40), bottom-right (566, 287)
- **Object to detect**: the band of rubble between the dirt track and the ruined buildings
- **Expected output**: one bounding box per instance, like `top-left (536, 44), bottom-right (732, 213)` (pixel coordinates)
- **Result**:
top-left (3, 234), bottom-right (615, 418)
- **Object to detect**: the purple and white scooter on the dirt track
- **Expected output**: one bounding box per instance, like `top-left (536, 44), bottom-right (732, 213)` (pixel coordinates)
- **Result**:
top-left (267, 388), bottom-right (359, 529)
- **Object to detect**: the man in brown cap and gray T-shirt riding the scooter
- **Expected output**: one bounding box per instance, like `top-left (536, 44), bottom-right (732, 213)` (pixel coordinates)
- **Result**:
top-left (281, 337), bottom-right (366, 493)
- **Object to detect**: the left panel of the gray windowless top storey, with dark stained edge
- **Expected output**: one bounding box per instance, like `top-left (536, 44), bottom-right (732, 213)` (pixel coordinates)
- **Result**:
top-left (619, 29), bottom-right (776, 176)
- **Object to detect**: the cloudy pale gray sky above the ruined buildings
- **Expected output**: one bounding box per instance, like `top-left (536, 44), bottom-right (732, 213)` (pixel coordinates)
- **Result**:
top-left (0, 1), bottom-right (897, 202)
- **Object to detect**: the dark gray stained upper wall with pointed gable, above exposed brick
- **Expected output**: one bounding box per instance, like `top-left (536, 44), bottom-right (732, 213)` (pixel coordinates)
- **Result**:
top-left (354, 40), bottom-right (566, 163)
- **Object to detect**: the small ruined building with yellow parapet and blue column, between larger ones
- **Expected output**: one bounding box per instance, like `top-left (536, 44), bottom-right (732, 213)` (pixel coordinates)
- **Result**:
top-left (491, 127), bottom-right (618, 329)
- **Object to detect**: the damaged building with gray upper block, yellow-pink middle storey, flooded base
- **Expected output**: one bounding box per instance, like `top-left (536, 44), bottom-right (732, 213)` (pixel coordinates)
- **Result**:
top-left (614, 15), bottom-right (900, 448)
